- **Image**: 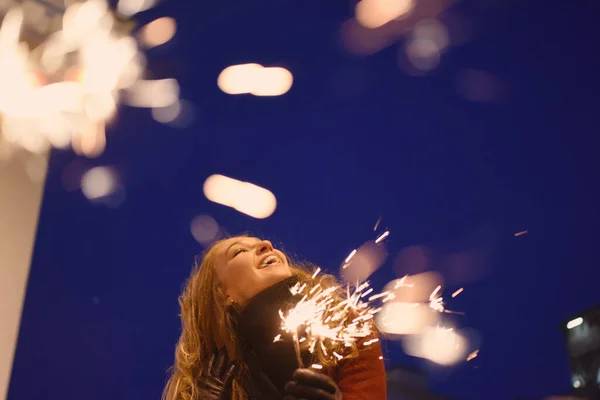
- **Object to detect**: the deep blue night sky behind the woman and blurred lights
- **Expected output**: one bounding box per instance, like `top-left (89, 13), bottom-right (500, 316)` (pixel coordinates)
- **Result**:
top-left (9, 0), bottom-right (600, 400)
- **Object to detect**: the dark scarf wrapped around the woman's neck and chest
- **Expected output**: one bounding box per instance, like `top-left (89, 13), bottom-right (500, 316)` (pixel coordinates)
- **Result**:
top-left (236, 277), bottom-right (310, 400)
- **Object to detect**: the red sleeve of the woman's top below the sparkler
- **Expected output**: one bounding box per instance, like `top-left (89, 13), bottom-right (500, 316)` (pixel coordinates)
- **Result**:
top-left (328, 342), bottom-right (387, 400)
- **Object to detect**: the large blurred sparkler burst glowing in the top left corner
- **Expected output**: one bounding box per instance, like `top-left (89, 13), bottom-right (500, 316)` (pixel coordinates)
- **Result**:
top-left (0, 0), bottom-right (179, 157)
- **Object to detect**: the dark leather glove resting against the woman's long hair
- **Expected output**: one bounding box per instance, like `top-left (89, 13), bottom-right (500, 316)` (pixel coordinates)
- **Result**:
top-left (199, 349), bottom-right (237, 400)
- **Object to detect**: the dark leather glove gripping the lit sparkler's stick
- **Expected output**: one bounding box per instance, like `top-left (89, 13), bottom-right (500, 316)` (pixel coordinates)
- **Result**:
top-left (285, 368), bottom-right (342, 400)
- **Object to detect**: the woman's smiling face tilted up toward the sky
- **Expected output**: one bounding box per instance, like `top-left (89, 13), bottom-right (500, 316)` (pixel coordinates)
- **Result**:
top-left (214, 237), bottom-right (292, 307)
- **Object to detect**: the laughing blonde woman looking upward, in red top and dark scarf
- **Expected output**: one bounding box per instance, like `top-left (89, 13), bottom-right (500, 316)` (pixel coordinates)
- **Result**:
top-left (163, 236), bottom-right (386, 400)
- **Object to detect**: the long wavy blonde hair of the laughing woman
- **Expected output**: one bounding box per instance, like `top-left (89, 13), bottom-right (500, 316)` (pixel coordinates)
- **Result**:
top-left (162, 235), bottom-right (358, 400)
